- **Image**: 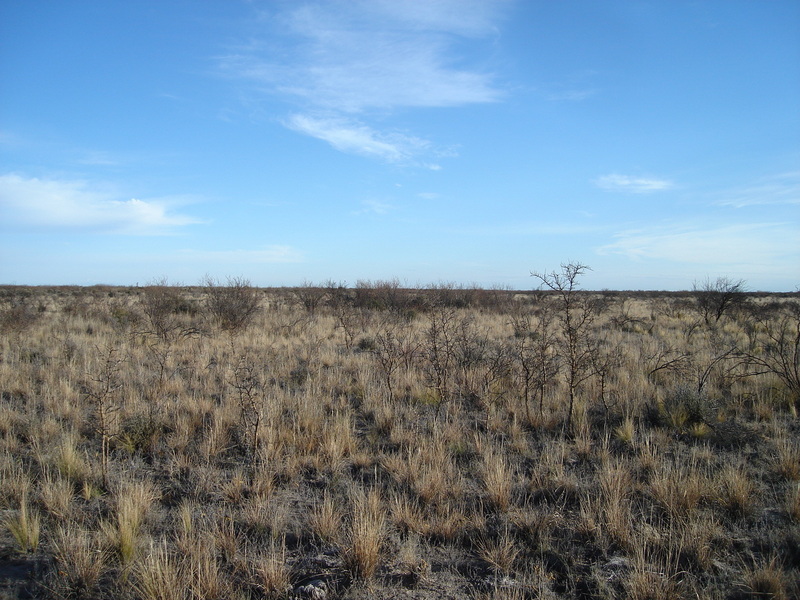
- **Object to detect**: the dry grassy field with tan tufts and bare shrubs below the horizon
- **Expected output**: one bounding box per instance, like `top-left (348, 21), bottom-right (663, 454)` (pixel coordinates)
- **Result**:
top-left (0, 280), bottom-right (800, 600)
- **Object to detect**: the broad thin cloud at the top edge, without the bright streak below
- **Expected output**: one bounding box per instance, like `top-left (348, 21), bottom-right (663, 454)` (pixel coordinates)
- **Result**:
top-left (268, 0), bottom-right (502, 113)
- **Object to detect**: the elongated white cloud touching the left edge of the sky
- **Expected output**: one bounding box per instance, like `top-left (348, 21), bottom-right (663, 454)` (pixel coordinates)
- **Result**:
top-left (0, 173), bottom-right (200, 235)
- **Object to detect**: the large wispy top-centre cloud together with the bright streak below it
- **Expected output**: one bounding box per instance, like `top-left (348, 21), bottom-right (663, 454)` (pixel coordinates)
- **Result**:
top-left (219, 0), bottom-right (507, 162)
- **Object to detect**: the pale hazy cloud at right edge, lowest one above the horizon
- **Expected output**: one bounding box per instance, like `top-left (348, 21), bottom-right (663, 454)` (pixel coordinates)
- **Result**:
top-left (598, 222), bottom-right (800, 266)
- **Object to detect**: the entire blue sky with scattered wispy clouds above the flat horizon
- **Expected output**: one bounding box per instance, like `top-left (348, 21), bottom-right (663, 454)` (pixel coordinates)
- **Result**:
top-left (0, 0), bottom-right (800, 291)
